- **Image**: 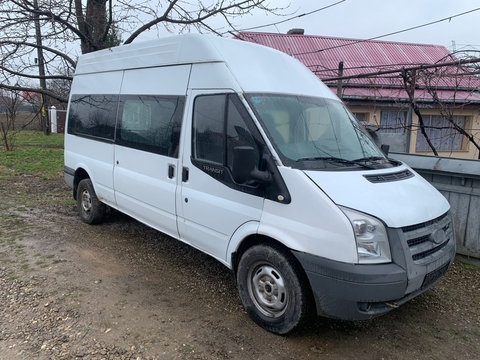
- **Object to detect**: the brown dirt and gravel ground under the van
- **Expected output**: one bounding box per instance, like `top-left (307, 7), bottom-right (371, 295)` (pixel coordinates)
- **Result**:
top-left (0, 176), bottom-right (480, 359)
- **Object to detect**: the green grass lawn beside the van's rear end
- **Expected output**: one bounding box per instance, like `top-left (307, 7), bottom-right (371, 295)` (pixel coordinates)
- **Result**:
top-left (0, 131), bottom-right (63, 178)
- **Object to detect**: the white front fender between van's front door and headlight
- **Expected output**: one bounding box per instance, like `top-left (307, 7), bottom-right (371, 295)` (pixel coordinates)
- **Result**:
top-left (258, 167), bottom-right (358, 264)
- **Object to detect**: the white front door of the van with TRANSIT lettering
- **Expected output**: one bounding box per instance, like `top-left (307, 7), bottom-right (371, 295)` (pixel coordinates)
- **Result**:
top-left (177, 90), bottom-right (264, 262)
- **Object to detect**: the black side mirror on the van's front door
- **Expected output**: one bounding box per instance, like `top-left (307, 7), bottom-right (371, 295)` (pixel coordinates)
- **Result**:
top-left (232, 146), bottom-right (272, 184)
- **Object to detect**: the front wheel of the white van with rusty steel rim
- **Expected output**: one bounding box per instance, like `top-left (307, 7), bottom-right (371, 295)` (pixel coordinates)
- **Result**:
top-left (237, 245), bottom-right (309, 335)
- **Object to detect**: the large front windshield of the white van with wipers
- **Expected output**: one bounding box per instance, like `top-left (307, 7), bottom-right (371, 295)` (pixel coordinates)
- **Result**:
top-left (246, 94), bottom-right (393, 170)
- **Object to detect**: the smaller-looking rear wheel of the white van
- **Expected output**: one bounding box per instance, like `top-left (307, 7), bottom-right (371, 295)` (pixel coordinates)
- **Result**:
top-left (77, 179), bottom-right (106, 224)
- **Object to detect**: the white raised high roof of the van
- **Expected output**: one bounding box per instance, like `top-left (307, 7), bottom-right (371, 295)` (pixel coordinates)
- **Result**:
top-left (75, 34), bottom-right (336, 99)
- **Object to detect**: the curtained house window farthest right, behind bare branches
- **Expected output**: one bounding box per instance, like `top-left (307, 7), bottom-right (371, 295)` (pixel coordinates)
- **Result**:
top-left (416, 115), bottom-right (467, 151)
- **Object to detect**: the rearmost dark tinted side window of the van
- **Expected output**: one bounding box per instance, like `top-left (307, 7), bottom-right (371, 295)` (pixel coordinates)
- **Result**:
top-left (67, 95), bottom-right (118, 141)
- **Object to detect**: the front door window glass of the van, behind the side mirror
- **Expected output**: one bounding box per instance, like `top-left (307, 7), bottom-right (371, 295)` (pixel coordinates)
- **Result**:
top-left (192, 94), bottom-right (260, 177)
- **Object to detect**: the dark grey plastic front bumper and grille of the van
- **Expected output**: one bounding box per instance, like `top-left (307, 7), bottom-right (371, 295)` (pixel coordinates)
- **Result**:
top-left (293, 215), bottom-right (455, 320)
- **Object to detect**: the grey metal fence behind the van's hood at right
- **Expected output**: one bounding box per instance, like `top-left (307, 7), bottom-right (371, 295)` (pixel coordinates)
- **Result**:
top-left (390, 153), bottom-right (480, 258)
